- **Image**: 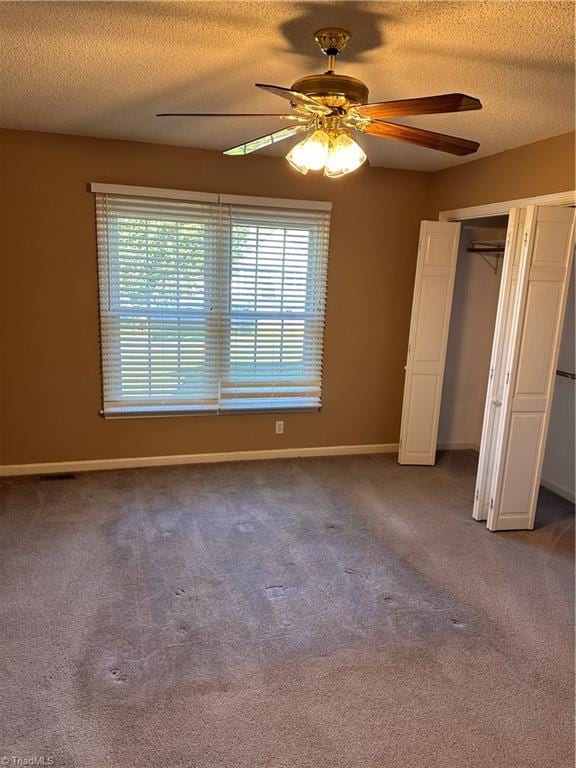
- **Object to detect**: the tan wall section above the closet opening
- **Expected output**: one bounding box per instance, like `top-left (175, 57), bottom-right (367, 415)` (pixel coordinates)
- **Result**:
top-left (430, 133), bottom-right (576, 212)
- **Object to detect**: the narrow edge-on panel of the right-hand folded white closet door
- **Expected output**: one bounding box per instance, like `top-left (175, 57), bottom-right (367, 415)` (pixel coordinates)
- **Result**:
top-left (472, 208), bottom-right (526, 520)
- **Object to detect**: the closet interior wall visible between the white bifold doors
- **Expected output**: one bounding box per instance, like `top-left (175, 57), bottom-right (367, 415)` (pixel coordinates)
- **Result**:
top-left (438, 217), bottom-right (507, 450)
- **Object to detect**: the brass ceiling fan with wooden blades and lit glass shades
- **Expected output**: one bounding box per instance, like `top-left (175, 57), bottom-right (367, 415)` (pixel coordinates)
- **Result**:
top-left (158, 27), bottom-right (482, 178)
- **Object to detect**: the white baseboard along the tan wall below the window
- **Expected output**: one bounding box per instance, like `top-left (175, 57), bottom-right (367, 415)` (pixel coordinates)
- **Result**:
top-left (0, 443), bottom-right (398, 477)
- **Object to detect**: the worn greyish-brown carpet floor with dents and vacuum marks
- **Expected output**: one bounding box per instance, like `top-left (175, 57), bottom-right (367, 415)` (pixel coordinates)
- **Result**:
top-left (0, 452), bottom-right (574, 768)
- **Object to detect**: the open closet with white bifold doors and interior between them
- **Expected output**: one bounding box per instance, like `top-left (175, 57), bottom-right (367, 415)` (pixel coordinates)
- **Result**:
top-left (398, 206), bottom-right (574, 530)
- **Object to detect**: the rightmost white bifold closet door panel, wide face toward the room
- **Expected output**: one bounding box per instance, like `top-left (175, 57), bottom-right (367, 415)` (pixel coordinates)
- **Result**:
top-left (488, 206), bottom-right (574, 531)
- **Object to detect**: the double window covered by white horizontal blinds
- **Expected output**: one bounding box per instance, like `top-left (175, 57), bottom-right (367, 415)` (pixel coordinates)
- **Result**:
top-left (92, 184), bottom-right (330, 416)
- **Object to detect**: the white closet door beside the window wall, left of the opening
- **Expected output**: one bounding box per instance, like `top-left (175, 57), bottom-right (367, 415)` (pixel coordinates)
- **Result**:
top-left (398, 221), bottom-right (460, 464)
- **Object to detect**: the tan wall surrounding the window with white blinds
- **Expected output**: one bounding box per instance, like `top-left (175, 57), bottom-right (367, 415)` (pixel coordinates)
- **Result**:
top-left (0, 131), bottom-right (430, 464)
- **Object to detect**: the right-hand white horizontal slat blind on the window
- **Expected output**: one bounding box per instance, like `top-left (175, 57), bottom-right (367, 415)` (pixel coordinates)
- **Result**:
top-left (221, 205), bottom-right (330, 410)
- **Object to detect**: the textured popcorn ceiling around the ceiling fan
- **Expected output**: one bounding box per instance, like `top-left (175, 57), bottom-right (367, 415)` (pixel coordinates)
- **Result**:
top-left (0, 0), bottom-right (574, 170)
